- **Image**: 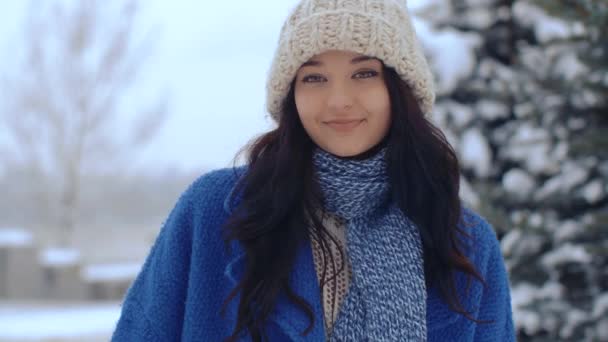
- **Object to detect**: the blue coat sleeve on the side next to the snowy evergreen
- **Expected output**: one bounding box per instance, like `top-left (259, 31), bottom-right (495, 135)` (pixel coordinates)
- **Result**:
top-left (474, 220), bottom-right (515, 342)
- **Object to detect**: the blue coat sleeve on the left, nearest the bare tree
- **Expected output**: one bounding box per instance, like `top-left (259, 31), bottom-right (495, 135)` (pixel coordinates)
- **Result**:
top-left (112, 182), bottom-right (193, 342)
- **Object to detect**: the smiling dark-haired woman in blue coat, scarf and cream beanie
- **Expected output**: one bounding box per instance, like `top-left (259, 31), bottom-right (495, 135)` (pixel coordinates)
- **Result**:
top-left (113, 0), bottom-right (514, 341)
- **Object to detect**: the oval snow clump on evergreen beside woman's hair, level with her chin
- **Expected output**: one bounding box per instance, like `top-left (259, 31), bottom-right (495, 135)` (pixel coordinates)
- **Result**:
top-left (460, 128), bottom-right (492, 177)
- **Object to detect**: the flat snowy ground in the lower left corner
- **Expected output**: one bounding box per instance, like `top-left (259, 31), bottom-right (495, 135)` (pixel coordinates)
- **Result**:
top-left (0, 302), bottom-right (120, 342)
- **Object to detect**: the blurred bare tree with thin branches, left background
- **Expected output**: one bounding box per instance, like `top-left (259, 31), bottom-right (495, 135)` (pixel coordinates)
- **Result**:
top-left (0, 0), bottom-right (167, 246)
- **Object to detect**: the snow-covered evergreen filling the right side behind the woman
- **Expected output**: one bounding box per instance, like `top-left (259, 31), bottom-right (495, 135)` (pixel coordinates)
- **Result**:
top-left (418, 0), bottom-right (608, 341)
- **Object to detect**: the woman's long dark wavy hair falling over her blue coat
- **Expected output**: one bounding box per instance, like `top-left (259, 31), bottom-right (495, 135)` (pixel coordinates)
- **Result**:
top-left (224, 67), bottom-right (484, 341)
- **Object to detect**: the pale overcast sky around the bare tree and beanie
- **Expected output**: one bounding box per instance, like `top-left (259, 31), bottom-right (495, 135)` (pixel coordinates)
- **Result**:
top-left (0, 0), bottom-right (427, 169)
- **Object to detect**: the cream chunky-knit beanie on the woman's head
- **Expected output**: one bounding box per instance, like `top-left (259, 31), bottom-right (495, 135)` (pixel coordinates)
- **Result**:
top-left (266, 0), bottom-right (435, 121)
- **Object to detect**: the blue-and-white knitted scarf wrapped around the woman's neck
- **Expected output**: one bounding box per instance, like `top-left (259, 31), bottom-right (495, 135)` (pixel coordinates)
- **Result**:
top-left (313, 148), bottom-right (427, 341)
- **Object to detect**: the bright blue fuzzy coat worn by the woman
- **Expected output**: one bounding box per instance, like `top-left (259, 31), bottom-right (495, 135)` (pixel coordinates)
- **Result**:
top-left (112, 169), bottom-right (515, 342)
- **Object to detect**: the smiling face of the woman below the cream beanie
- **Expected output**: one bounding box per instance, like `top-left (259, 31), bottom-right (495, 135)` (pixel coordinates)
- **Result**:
top-left (294, 51), bottom-right (391, 157)
